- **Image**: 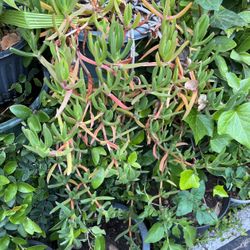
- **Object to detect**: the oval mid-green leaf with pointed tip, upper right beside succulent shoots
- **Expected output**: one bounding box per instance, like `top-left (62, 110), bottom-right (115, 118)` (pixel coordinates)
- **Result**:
top-left (209, 36), bottom-right (237, 52)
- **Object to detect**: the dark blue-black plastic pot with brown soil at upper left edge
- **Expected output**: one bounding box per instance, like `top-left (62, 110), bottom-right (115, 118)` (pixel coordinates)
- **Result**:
top-left (0, 37), bottom-right (27, 104)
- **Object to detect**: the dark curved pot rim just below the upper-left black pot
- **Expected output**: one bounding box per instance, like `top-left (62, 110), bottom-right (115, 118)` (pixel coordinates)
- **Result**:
top-left (0, 70), bottom-right (49, 134)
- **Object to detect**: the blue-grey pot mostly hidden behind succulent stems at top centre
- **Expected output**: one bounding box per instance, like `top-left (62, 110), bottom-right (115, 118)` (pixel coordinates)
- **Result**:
top-left (78, 24), bottom-right (151, 81)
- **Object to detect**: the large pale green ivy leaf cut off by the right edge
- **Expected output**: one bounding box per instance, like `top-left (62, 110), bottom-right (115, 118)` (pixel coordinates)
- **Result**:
top-left (218, 102), bottom-right (250, 148)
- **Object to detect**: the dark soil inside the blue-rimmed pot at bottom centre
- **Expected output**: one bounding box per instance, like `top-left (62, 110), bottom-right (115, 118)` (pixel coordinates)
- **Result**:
top-left (81, 219), bottom-right (141, 250)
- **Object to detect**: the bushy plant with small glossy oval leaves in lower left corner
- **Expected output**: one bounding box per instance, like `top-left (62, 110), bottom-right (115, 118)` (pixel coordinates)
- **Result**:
top-left (0, 134), bottom-right (44, 249)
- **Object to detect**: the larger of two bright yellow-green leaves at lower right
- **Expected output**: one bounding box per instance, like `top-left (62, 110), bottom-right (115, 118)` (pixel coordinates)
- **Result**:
top-left (180, 169), bottom-right (200, 190)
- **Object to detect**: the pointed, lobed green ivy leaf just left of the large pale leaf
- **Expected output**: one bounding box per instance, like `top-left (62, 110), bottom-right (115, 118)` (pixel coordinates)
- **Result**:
top-left (185, 110), bottom-right (214, 144)
